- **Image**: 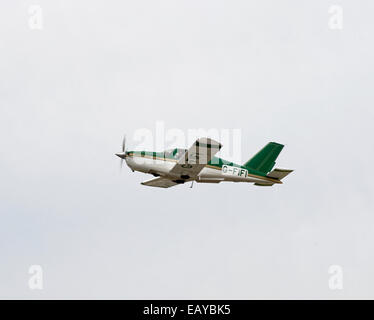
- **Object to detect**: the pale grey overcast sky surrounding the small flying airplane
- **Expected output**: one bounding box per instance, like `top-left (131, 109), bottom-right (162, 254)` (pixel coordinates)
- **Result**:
top-left (0, 0), bottom-right (374, 299)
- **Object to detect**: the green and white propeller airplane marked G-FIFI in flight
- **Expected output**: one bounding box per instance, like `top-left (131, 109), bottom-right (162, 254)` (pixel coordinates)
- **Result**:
top-left (116, 138), bottom-right (293, 188)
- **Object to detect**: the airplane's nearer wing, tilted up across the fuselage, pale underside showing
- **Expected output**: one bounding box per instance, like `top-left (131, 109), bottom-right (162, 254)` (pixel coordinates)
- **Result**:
top-left (170, 138), bottom-right (222, 179)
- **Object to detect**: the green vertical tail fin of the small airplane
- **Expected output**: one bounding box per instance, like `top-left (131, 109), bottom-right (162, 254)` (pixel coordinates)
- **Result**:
top-left (244, 142), bottom-right (284, 174)
